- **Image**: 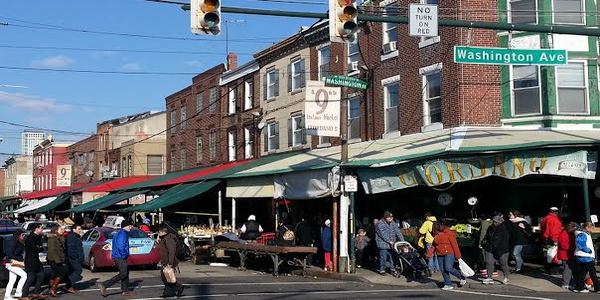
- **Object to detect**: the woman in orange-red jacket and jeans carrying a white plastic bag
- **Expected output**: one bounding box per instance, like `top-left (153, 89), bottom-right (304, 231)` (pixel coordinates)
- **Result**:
top-left (426, 222), bottom-right (467, 291)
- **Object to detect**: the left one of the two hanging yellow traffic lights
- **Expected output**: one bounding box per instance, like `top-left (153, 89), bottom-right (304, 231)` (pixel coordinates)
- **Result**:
top-left (190, 0), bottom-right (221, 35)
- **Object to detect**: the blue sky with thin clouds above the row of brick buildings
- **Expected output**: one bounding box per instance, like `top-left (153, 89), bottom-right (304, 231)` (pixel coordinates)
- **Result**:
top-left (0, 0), bottom-right (327, 161)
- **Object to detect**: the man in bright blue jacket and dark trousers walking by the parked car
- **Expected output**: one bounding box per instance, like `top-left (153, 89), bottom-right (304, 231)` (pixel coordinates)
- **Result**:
top-left (98, 220), bottom-right (134, 297)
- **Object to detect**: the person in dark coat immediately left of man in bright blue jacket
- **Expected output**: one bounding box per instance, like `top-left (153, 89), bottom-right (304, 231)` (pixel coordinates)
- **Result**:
top-left (65, 224), bottom-right (83, 294)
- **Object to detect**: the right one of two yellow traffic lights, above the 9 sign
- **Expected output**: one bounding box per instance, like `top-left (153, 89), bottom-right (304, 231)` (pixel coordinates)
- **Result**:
top-left (329, 0), bottom-right (358, 43)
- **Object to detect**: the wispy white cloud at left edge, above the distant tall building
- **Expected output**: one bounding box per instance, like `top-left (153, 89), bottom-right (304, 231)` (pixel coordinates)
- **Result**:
top-left (0, 91), bottom-right (71, 114)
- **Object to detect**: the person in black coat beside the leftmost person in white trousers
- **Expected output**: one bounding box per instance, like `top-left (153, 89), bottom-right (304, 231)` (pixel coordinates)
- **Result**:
top-left (23, 224), bottom-right (48, 299)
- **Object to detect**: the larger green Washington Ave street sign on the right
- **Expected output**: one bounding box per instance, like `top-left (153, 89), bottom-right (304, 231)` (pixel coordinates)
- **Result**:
top-left (454, 46), bottom-right (568, 66)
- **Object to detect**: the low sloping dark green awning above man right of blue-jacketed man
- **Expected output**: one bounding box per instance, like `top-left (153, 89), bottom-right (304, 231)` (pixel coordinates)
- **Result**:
top-left (124, 180), bottom-right (220, 212)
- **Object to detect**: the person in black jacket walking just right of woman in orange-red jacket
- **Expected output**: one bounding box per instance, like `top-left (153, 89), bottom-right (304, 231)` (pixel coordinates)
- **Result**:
top-left (482, 216), bottom-right (510, 284)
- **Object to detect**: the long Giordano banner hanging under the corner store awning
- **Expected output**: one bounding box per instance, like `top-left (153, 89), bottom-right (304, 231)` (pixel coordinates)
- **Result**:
top-left (358, 149), bottom-right (598, 194)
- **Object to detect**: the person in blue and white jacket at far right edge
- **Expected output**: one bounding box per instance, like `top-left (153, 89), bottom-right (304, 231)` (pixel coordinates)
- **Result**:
top-left (573, 223), bottom-right (600, 293)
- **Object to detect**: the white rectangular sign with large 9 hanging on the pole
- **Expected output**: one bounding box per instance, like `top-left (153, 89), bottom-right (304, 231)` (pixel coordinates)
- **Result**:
top-left (304, 86), bottom-right (341, 137)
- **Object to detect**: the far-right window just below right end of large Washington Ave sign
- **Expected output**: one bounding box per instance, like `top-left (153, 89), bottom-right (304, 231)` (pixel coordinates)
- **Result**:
top-left (556, 62), bottom-right (588, 114)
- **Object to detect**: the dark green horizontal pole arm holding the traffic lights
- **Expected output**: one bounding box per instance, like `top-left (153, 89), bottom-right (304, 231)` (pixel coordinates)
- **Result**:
top-left (182, 5), bottom-right (600, 37)
